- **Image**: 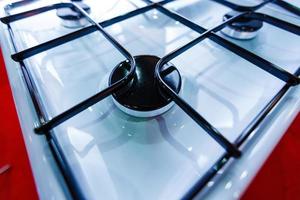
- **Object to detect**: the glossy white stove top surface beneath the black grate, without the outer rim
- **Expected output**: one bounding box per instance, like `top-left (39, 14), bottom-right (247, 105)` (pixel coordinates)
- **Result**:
top-left (0, 0), bottom-right (300, 199)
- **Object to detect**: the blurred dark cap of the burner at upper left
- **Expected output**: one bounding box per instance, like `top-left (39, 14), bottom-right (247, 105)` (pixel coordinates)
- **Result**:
top-left (56, 0), bottom-right (91, 20)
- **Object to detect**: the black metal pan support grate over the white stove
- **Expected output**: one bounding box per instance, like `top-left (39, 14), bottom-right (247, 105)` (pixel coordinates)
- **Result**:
top-left (0, 0), bottom-right (300, 199)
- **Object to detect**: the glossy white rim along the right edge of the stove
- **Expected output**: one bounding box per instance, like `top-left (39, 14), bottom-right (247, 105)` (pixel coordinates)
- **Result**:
top-left (196, 83), bottom-right (300, 200)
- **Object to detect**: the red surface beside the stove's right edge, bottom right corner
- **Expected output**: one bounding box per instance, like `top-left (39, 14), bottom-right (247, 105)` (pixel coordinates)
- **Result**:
top-left (242, 114), bottom-right (300, 200)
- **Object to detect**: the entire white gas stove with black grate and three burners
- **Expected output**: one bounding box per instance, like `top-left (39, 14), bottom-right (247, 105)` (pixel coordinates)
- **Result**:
top-left (0, 0), bottom-right (300, 199)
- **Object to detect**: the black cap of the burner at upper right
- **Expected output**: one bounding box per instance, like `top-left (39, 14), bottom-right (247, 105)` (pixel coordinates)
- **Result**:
top-left (223, 11), bottom-right (263, 32)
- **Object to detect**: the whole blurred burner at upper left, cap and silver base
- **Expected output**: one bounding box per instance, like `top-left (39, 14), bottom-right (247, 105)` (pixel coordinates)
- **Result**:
top-left (56, 0), bottom-right (91, 28)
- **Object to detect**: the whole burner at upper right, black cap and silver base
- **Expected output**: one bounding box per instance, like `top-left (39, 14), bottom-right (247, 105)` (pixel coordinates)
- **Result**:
top-left (221, 11), bottom-right (263, 40)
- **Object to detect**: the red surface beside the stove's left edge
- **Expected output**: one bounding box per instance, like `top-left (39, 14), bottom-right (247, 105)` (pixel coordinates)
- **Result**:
top-left (0, 48), bottom-right (38, 200)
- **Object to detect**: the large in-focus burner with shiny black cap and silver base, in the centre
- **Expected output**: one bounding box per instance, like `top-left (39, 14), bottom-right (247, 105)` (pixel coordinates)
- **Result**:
top-left (109, 55), bottom-right (181, 117)
